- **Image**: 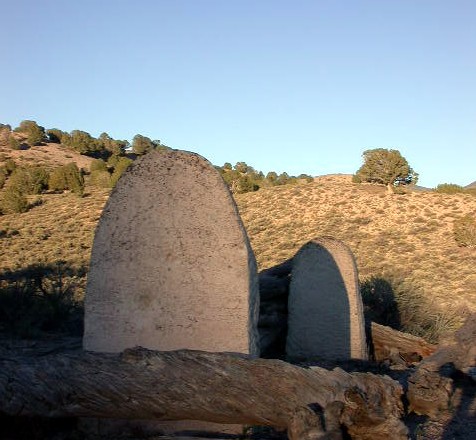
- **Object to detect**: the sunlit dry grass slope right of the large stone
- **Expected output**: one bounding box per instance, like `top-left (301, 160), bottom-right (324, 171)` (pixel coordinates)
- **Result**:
top-left (236, 175), bottom-right (476, 312)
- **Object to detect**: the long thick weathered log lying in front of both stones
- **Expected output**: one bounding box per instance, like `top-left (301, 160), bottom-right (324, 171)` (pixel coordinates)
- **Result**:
top-left (0, 347), bottom-right (407, 440)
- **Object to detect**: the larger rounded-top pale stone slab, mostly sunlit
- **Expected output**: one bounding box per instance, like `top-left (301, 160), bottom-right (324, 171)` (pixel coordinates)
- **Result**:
top-left (84, 151), bottom-right (259, 355)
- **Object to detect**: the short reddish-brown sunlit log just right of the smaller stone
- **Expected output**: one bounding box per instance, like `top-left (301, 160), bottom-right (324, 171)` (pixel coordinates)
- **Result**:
top-left (370, 322), bottom-right (436, 365)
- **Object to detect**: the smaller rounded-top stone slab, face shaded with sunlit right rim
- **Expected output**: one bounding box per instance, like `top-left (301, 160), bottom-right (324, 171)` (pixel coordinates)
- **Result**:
top-left (286, 238), bottom-right (368, 360)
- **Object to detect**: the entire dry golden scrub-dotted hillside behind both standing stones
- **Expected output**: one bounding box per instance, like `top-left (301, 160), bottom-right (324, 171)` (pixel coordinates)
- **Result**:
top-left (0, 148), bottom-right (476, 340)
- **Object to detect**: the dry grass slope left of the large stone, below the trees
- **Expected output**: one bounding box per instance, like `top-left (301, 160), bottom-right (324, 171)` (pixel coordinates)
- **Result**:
top-left (0, 188), bottom-right (109, 280)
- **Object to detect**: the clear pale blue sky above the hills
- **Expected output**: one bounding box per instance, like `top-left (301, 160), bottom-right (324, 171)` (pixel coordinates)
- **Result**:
top-left (0, 0), bottom-right (476, 187)
